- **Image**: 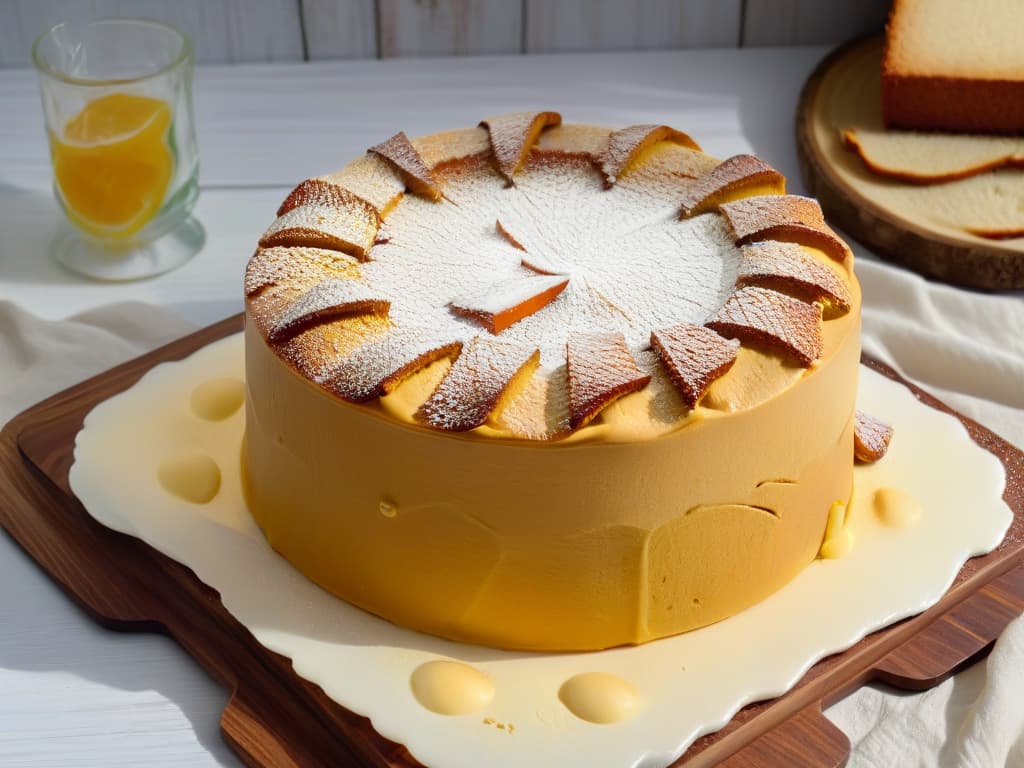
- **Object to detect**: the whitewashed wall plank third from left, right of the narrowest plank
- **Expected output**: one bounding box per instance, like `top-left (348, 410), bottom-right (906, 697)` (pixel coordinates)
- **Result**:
top-left (377, 0), bottom-right (522, 58)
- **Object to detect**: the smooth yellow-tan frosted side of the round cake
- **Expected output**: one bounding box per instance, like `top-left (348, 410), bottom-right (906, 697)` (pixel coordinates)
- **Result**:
top-left (245, 307), bottom-right (859, 649)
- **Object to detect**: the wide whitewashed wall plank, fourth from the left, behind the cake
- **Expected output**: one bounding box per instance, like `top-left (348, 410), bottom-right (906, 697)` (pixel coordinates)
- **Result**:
top-left (524, 0), bottom-right (741, 53)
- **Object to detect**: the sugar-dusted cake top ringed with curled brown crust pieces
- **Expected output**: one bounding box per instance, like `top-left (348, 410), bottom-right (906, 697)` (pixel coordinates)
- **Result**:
top-left (246, 112), bottom-right (856, 440)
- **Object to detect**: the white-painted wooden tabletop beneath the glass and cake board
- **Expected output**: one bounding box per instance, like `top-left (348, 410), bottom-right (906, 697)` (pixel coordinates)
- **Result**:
top-left (0, 48), bottom-right (1015, 768)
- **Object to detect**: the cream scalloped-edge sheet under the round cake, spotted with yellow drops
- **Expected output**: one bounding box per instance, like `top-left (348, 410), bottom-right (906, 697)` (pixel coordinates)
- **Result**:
top-left (71, 336), bottom-right (1012, 768)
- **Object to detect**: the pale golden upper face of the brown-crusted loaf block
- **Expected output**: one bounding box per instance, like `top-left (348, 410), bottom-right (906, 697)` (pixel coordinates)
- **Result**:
top-left (885, 0), bottom-right (1024, 81)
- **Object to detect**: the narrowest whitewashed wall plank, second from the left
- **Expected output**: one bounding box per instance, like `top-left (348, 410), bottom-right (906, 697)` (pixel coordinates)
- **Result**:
top-left (299, 0), bottom-right (378, 61)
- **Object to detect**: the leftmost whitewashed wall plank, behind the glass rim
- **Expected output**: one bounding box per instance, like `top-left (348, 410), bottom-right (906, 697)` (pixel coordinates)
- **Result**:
top-left (0, 0), bottom-right (303, 68)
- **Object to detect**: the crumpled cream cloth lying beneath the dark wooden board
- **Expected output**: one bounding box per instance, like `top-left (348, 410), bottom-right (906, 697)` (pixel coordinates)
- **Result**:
top-left (0, 278), bottom-right (1024, 768)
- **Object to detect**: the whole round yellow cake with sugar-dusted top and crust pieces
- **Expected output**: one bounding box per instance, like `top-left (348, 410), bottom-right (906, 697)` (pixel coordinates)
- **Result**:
top-left (243, 113), bottom-right (860, 650)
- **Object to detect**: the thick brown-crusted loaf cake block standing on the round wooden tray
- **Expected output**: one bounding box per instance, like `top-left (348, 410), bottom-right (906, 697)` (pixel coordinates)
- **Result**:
top-left (882, 0), bottom-right (1024, 133)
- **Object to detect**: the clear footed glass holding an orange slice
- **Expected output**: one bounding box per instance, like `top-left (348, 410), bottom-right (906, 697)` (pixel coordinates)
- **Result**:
top-left (33, 18), bottom-right (204, 281)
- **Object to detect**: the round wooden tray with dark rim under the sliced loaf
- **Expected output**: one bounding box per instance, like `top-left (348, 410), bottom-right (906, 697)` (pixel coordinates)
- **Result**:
top-left (797, 37), bottom-right (1024, 291)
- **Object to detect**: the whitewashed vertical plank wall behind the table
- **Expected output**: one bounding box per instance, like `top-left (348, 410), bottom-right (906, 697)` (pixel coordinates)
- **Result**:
top-left (0, 0), bottom-right (890, 68)
